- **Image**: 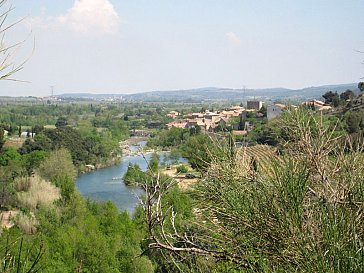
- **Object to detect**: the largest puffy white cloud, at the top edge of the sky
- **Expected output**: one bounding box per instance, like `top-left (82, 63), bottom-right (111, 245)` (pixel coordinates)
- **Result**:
top-left (30, 0), bottom-right (120, 36)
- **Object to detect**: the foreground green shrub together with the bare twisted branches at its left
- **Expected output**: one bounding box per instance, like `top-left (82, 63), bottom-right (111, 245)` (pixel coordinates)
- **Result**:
top-left (141, 109), bottom-right (364, 272)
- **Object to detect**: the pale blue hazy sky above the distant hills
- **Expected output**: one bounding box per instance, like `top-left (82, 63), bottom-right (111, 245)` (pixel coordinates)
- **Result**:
top-left (0, 0), bottom-right (364, 96)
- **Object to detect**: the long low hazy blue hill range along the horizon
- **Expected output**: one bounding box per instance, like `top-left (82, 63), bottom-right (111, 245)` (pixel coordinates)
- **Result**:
top-left (58, 83), bottom-right (359, 102)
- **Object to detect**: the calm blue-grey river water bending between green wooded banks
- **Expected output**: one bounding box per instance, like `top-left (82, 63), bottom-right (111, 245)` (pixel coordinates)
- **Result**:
top-left (76, 147), bottom-right (186, 215)
